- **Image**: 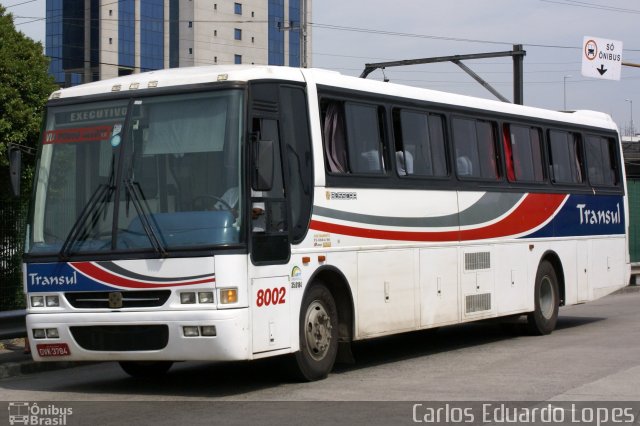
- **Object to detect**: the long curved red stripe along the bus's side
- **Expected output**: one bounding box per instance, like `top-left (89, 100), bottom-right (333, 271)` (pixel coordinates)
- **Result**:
top-left (311, 194), bottom-right (568, 242)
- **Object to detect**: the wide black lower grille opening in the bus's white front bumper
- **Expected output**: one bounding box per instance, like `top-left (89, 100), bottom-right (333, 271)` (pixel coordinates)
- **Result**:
top-left (70, 325), bottom-right (169, 352)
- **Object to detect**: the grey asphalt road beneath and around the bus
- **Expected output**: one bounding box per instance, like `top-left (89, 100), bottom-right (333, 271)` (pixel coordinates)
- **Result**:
top-left (0, 291), bottom-right (640, 425)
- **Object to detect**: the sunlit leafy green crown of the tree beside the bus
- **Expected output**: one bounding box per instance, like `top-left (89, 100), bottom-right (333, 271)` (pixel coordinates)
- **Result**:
top-left (0, 5), bottom-right (56, 169)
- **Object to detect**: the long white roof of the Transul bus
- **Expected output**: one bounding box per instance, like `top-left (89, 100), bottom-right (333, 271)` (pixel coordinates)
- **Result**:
top-left (51, 65), bottom-right (617, 131)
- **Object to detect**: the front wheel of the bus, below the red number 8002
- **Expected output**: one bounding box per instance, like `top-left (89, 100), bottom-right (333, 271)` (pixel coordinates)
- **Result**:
top-left (295, 282), bottom-right (338, 381)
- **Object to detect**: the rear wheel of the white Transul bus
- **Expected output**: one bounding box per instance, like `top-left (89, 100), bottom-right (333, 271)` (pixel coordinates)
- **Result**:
top-left (527, 260), bottom-right (560, 336)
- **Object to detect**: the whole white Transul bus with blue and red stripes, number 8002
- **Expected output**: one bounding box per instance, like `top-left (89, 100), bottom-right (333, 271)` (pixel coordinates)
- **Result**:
top-left (24, 66), bottom-right (630, 380)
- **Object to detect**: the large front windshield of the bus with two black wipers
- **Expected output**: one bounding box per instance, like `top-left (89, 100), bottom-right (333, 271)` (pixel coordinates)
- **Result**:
top-left (26, 90), bottom-right (243, 259)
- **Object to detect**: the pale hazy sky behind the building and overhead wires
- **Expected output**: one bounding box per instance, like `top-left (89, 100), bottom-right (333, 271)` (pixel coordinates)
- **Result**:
top-left (1, 0), bottom-right (640, 135)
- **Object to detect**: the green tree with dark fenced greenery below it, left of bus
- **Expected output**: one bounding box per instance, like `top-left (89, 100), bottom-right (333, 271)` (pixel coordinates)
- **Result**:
top-left (0, 5), bottom-right (56, 311)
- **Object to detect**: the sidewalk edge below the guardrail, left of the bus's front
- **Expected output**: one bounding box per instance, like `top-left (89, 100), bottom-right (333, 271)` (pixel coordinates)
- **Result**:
top-left (0, 338), bottom-right (79, 380)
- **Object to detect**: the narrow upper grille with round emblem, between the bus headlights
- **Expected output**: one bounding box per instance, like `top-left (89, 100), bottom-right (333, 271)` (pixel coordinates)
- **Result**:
top-left (64, 290), bottom-right (171, 309)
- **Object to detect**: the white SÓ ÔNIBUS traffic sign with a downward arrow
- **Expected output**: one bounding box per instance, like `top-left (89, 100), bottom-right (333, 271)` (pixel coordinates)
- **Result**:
top-left (581, 36), bottom-right (622, 80)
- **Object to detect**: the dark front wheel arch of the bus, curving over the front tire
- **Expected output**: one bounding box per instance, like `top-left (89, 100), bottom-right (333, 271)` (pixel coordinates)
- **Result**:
top-left (303, 266), bottom-right (355, 342)
